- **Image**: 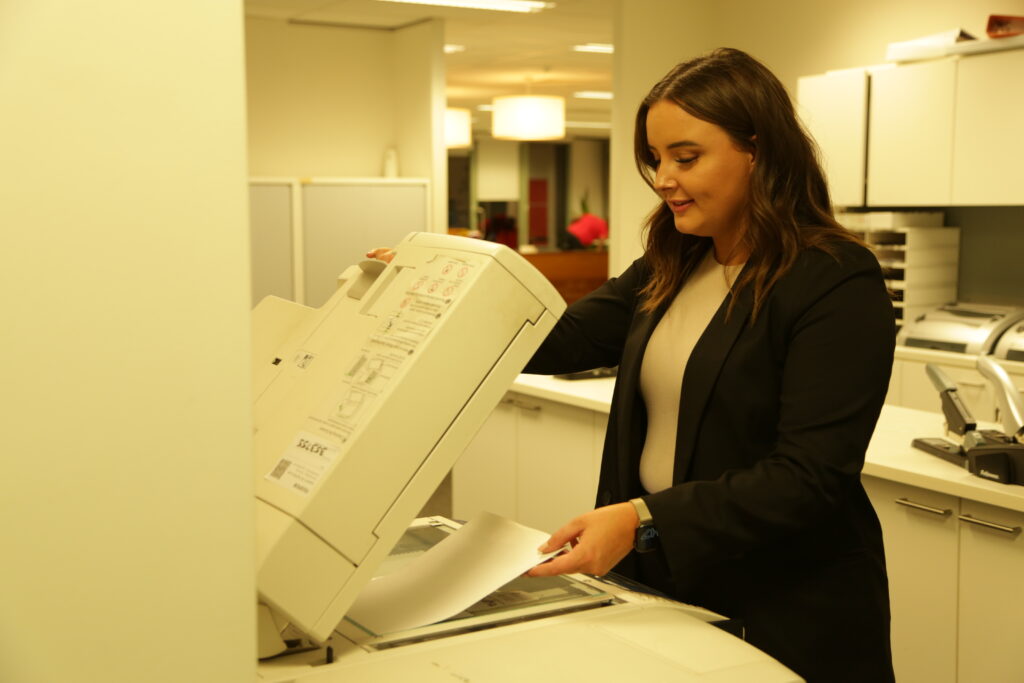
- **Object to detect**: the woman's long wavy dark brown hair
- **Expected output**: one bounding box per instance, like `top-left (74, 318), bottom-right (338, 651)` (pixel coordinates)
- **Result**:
top-left (634, 48), bottom-right (860, 316)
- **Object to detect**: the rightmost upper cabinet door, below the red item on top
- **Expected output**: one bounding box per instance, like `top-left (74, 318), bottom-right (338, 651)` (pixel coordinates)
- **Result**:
top-left (952, 50), bottom-right (1024, 205)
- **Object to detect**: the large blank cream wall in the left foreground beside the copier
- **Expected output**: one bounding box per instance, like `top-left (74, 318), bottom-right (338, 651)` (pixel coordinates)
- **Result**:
top-left (0, 0), bottom-right (256, 683)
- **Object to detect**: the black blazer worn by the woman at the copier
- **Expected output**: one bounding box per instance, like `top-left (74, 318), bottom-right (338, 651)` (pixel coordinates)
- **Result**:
top-left (525, 243), bottom-right (895, 681)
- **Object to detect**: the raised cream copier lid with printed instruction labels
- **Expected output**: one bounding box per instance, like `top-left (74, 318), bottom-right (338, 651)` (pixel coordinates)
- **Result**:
top-left (252, 232), bottom-right (565, 655)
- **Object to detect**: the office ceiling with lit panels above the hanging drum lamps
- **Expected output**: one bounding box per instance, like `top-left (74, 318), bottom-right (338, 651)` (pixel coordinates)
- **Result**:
top-left (245, 0), bottom-right (614, 137)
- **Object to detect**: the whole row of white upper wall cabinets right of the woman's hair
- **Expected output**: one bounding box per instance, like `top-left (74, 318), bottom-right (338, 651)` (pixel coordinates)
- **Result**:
top-left (797, 49), bottom-right (1024, 207)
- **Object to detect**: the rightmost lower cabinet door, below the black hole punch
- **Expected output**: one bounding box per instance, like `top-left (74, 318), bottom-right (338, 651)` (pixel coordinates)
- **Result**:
top-left (959, 501), bottom-right (1024, 683)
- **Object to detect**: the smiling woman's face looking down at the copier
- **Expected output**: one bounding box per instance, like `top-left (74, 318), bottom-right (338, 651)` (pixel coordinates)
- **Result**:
top-left (647, 99), bottom-right (754, 262)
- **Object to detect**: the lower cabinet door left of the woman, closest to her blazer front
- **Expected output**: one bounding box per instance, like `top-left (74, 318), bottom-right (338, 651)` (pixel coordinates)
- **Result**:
top-left (516, 397), bottom-right (600, 532)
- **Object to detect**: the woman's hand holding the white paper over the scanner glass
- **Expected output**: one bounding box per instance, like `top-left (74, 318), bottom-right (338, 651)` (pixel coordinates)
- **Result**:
top-left (526, 503), bottom-right (639, 577)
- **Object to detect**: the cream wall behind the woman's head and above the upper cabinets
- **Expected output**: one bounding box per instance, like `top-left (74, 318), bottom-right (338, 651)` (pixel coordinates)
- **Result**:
top-left (609, 0), bottom-right (1024, 274)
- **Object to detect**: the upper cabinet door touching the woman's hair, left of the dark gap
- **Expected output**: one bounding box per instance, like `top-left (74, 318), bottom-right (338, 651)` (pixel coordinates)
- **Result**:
top-left (797, 69), bottom-right (867, 207)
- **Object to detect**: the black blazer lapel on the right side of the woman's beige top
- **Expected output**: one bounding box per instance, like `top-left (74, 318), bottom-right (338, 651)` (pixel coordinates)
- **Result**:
top-left (672, 286), bottom-right (754, 484)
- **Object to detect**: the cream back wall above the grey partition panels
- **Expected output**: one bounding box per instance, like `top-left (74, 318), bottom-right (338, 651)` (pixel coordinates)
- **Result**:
top-left (246, 17), bottom-right (447, 231)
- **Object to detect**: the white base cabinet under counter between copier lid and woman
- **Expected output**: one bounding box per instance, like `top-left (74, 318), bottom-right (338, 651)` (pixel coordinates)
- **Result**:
top-left (452, 392), bottom-right (607, 532)
